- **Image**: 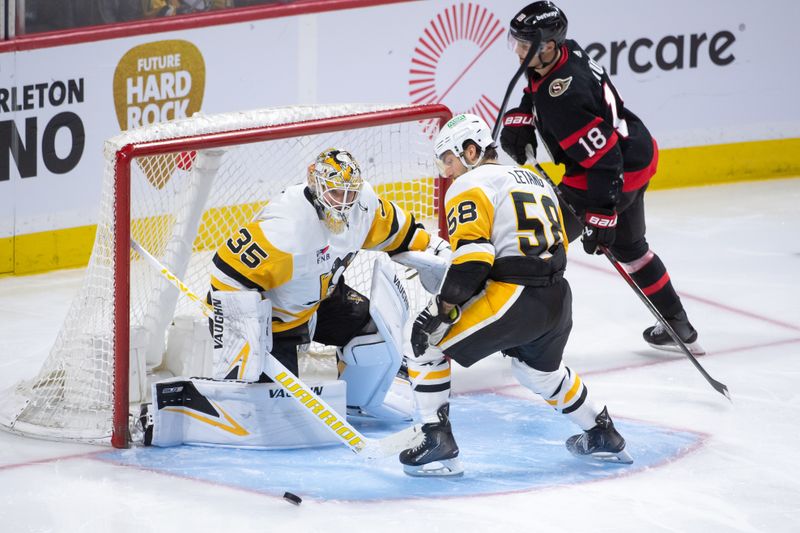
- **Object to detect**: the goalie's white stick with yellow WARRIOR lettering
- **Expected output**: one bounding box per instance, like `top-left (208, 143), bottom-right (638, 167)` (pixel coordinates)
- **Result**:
top-left (131, 238), bottom-right (422, 459)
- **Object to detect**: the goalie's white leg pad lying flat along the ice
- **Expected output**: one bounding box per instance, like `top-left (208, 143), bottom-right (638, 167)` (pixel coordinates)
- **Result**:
top-left (149, 378), bottom-right (345, 449)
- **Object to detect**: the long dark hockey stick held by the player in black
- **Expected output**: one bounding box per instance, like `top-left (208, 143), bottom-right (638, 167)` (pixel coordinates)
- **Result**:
top-left (492, 53), bottom-right (733, 403)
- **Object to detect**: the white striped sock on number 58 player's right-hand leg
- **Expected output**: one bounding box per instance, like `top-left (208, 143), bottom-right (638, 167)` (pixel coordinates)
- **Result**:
top-left (511, 358), bottom-right (600, 430)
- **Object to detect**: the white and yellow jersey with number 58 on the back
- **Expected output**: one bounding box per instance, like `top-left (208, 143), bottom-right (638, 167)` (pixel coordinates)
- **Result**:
top-left (445, 164), bottom-right (566, 267)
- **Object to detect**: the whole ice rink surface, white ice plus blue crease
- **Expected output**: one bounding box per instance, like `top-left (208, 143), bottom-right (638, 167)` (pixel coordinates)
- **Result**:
top-left (0, 179), bottom-right (800, 533)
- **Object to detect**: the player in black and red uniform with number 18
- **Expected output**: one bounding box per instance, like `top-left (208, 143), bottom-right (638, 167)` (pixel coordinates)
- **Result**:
top-left (500, 1), bottom-right (704, 355)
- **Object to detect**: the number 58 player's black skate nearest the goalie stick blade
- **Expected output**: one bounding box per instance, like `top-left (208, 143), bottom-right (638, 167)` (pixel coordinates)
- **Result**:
top-left (400, 404), bottom-right (464, 477)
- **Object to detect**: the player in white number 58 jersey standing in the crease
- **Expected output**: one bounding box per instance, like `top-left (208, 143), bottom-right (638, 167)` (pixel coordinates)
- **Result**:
top-left (400, 114), bottom-right (632, 476)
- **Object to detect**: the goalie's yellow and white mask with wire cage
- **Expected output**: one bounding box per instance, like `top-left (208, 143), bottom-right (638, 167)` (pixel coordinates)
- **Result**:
top-left (308, 148), bottom-right (364, 233)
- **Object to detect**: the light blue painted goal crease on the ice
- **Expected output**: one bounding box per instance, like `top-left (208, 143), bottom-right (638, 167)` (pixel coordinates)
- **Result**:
top-left (96, 393), bottom-right (705, 502)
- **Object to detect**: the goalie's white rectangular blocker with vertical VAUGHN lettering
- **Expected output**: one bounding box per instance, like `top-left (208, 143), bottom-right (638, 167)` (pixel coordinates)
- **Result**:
top-left (209, 291), bottom-right (272, 381)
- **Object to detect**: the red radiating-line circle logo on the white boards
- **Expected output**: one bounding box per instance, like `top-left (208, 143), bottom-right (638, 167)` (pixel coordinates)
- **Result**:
top-left (408, 2), bottom-right (505, 135)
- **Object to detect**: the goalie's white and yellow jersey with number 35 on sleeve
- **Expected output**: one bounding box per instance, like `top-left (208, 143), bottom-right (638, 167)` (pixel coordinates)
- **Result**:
top-left (211, 182), bottom-right (430, 332)
